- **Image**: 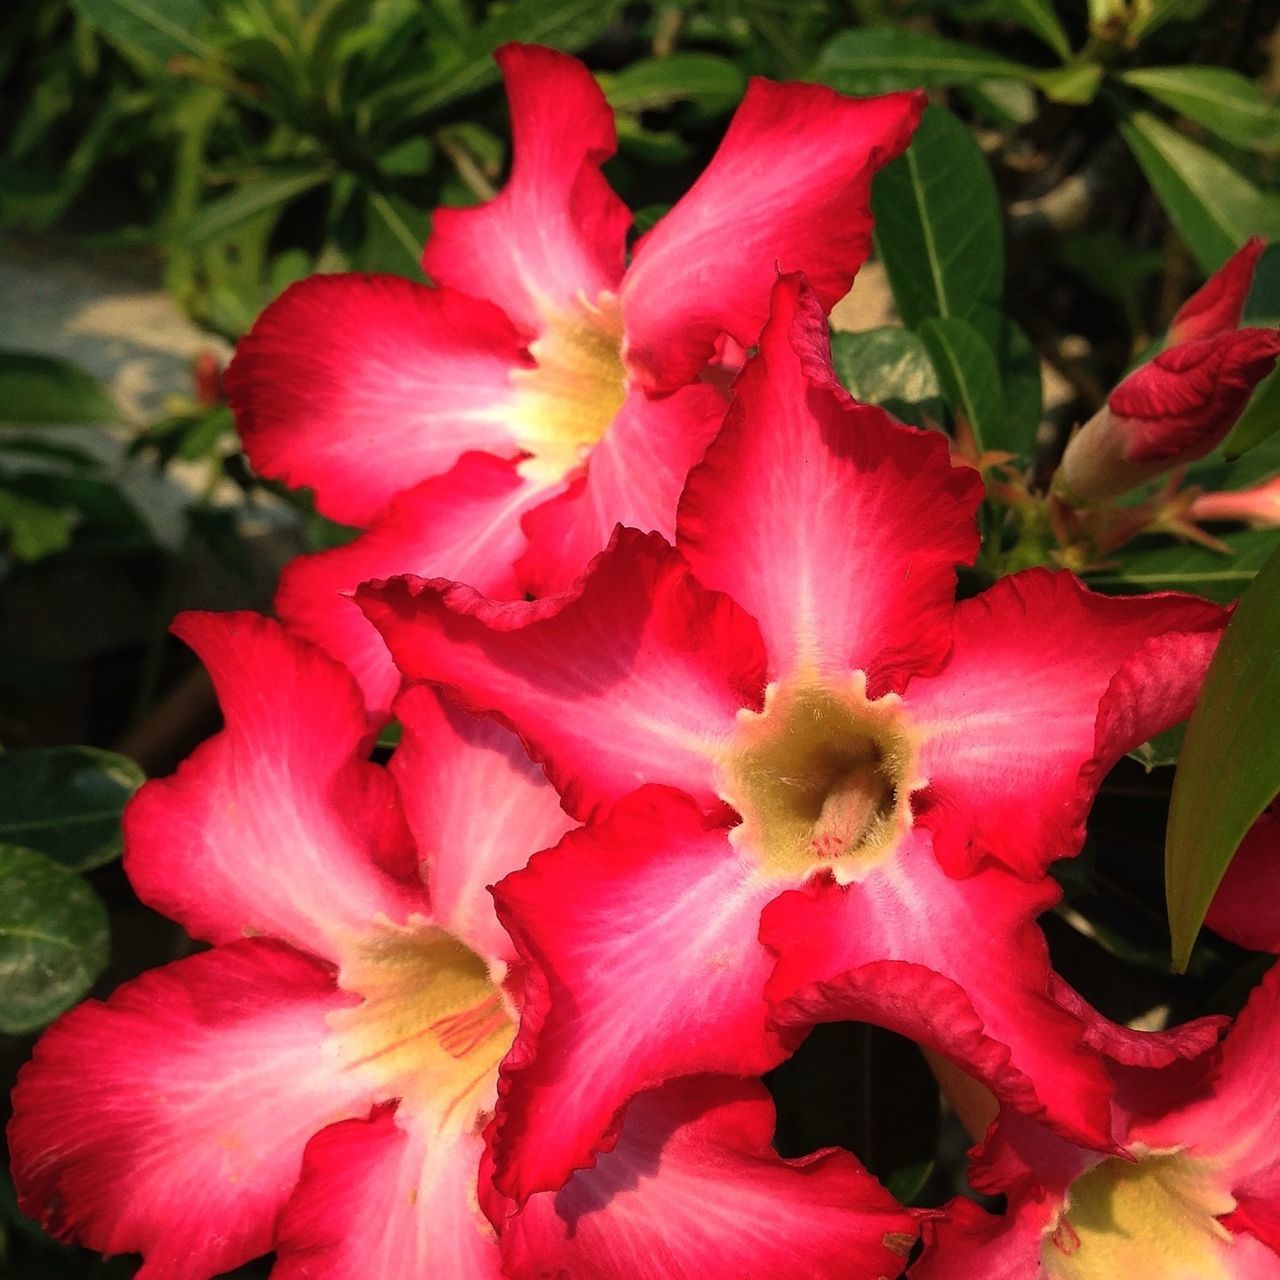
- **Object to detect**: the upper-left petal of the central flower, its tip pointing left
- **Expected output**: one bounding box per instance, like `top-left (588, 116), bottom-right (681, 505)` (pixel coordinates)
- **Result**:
top-left (356, 529), bottom-right (764, 820)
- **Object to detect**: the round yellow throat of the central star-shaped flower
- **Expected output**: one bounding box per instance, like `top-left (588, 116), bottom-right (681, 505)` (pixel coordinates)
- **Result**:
top-left (718, 672), bottom-right (922, 883)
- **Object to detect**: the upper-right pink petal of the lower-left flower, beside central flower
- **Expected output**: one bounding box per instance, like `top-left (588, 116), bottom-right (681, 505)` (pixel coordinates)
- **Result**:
top-left (390, 685), bottom-right (577, 963)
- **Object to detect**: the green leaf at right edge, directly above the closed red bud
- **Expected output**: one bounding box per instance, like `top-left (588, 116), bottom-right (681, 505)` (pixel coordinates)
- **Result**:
top-left (1120, 111), bottom-right (1280, 273)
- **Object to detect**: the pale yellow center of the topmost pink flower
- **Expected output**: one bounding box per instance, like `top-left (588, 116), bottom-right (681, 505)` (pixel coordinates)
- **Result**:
top-left (511, 293), bottom-right (627, 484)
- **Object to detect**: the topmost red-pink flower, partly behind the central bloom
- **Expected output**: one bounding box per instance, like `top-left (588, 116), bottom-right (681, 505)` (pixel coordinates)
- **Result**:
top-left (227, 45), bottom-right (923, 712)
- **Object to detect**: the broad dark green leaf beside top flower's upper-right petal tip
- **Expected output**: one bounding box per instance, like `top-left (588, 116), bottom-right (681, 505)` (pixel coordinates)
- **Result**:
top-left (872, 106), bottom-right (1005, 329)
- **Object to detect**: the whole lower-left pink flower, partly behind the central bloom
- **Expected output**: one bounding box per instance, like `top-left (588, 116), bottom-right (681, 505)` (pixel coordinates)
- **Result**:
top-left (9, 614), bottom-right (914, 1280)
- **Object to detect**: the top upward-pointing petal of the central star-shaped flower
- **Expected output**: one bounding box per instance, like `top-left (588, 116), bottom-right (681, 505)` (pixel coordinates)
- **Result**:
top-left (677, 275), bottom-right (983, 696)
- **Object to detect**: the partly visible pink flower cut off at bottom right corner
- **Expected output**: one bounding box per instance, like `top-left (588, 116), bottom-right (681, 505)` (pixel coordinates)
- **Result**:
top-left (910, 969), bottom-right (1280, 1280)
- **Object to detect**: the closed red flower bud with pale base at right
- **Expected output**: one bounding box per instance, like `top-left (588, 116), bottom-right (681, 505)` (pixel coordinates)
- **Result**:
top-left (1055, 238), bottom-right (1280, 504)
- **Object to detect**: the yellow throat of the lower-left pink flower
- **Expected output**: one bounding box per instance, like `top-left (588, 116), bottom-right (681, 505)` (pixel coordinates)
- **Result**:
top-left (330, 924), bottom-right (515, 1129)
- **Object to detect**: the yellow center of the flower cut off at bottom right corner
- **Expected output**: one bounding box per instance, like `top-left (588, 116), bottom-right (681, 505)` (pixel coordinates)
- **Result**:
top-left (1042, 1155), bottom-right (1235, 1280)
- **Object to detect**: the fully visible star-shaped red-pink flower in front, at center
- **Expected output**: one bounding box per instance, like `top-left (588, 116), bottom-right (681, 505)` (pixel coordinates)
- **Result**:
top-left (358, 276), bottom-right (1225, 1198)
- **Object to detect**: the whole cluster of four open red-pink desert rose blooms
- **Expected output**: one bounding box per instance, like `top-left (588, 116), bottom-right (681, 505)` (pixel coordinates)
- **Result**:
top-left (10, 46), bottom-right (1280, 1280)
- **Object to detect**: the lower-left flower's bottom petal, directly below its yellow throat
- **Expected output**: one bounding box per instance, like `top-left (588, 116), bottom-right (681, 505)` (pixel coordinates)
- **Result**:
top-left (271, 1107), bottom-right (503, 1280)
